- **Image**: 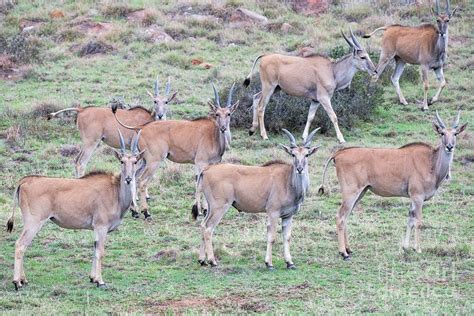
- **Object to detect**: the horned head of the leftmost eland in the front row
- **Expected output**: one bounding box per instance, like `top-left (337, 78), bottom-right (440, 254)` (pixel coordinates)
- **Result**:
top-left (114, 130), bottom-right (144, 185)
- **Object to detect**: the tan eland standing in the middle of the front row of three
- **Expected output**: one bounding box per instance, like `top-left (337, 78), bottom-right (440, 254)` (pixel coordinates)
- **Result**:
top-left (192, 128), bottom-right (319, 269)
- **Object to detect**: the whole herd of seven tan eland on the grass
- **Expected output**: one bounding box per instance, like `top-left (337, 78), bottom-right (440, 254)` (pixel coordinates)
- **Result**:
top-left (7, 0), bottom-right (467, 290)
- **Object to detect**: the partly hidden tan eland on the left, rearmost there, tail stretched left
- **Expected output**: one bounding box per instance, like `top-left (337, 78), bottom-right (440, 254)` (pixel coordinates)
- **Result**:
top-left (48, 78), bottom-right (177, 177)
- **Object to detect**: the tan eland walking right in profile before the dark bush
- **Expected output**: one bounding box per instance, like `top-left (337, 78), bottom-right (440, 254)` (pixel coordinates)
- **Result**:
top-left (244, 30), bottom-right (375, 143)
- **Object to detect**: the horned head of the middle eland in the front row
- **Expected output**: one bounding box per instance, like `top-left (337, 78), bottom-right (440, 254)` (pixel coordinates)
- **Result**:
top-left (280, 127), bottom-right (320, 175)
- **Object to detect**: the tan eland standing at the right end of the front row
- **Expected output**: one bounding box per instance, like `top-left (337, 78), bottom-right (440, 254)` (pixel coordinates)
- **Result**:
top-left (319, 112), bottom-right (467, 260)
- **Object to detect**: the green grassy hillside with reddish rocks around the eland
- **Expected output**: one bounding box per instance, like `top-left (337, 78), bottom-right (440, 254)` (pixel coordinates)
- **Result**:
top-left (0, 0), bottom-right (474, 314)
